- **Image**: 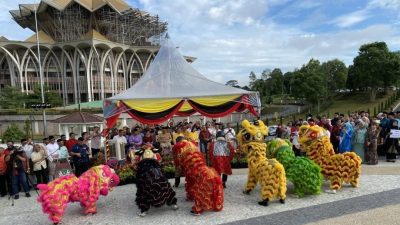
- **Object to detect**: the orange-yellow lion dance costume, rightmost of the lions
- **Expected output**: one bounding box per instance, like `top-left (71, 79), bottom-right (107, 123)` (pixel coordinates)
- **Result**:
top-left (299, 125), bottom-right (361, 193)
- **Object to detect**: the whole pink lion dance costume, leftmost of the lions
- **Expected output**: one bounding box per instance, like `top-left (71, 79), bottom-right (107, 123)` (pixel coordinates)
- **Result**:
top-left (38, 165), bottom-right (119, 224)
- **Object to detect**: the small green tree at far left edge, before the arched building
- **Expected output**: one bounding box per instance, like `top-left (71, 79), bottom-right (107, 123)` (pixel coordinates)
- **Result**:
top-left (0, 86), bottom-right (26, 109)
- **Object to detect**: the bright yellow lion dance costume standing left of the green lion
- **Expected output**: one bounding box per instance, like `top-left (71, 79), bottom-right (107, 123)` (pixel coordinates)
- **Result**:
top-left (237, 120), bottom-right (286, 206)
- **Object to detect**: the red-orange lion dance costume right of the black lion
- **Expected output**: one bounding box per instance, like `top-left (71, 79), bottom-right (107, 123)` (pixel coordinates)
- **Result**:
top-left (174, 141), bottom-right (224, 216)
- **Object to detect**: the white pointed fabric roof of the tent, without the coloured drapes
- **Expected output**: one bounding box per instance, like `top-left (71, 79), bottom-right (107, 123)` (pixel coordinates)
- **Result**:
top-left (108, 39), bottom-right (255, 100)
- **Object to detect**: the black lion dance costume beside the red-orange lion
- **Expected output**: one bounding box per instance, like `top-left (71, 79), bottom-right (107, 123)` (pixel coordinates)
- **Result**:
top-left (136, 146), bottom-right (178, 216)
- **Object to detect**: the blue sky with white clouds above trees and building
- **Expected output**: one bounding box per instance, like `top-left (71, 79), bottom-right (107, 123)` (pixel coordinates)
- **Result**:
top-left (0, 0), bottom-right (400, 85)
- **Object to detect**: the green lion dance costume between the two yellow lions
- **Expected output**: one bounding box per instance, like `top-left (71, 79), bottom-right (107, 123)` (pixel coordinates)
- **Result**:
top-left (267, 138), bottom-right (322, 197)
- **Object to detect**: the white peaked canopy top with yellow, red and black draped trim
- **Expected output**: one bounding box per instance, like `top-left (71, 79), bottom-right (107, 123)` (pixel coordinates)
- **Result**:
top-left (103, 38), bottom-right (261, 127)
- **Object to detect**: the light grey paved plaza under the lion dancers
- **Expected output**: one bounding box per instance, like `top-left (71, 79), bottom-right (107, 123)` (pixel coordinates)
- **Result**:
top-left (0, 160), bottom-right (400, 225)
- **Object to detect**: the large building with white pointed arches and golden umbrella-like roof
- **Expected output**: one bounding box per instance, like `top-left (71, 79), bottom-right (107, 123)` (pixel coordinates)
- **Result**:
top-left (0, 0), bottom-right (194, 105)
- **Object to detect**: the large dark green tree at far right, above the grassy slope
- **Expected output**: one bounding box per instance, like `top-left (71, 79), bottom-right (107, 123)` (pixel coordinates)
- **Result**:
top-left (349, 42), bottom-right (400, 101)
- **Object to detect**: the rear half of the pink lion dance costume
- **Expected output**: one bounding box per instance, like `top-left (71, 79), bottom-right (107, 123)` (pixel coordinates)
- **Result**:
top-left (37, 175), bottom-right (78, 224)
